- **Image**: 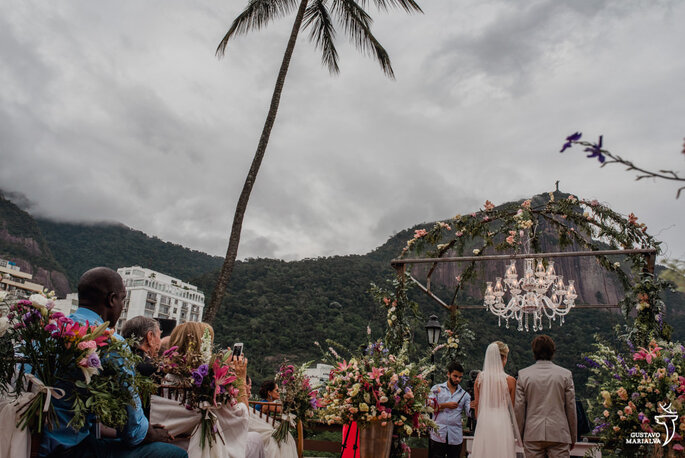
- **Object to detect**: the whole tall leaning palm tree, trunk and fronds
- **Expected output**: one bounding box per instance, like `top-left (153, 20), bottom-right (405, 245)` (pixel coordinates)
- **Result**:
top-left (204, 0), bottom-right (422, 322)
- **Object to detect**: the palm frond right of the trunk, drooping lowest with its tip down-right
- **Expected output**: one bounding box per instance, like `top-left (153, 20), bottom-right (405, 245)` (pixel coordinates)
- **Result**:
top-left (332, 0), bottom-right (395, 79)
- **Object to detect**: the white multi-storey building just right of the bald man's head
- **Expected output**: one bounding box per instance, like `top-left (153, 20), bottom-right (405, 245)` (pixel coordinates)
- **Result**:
top-left (117, 266), bottom-right (205, 331)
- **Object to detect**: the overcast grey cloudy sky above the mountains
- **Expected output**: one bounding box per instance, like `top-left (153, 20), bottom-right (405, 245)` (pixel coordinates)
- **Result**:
top-left (0, 0), bottom-right (685, 259)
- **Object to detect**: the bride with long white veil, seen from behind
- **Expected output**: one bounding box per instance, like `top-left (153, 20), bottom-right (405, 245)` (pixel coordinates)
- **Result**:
top-left (471, 342), bottom-right (521, 458)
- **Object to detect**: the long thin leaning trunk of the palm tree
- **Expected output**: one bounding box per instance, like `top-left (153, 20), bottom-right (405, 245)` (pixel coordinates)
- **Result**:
top-left (203, 0), bottom-right (308, 323)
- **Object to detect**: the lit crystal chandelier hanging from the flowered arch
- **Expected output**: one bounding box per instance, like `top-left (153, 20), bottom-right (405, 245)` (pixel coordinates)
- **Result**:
top-left (484, 258), bottom-right (578, 331)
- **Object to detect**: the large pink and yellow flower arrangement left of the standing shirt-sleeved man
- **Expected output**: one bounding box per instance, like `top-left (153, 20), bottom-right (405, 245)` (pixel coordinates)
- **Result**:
top-left (320, 341), bottom-right (435, 456)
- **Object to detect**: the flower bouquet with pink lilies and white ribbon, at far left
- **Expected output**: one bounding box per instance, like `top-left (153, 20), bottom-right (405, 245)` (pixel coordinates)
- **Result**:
top-left (0, 294), bottom-right (143, 433)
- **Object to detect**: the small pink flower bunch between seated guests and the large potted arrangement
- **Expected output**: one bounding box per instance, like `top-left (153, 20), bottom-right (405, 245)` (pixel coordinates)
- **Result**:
top-left (273, 363), bottom-right (320, 444)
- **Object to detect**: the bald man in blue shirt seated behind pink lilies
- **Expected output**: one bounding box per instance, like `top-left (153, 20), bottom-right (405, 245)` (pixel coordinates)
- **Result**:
top-left (40, 267), bottom-right (188, 458)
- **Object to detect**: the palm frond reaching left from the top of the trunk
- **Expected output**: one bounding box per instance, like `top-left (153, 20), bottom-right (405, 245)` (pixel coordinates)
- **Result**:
top-left (216, 0), bottom-right (298, 57)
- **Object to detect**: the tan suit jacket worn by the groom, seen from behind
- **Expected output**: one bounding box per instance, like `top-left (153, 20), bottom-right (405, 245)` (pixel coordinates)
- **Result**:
top-left (514, 361), bottom-right (577, 444)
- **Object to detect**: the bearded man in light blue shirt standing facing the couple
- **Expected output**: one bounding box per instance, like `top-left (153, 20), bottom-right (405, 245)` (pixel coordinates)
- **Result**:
top-left (429, 362), bottom-right (471, 458)
